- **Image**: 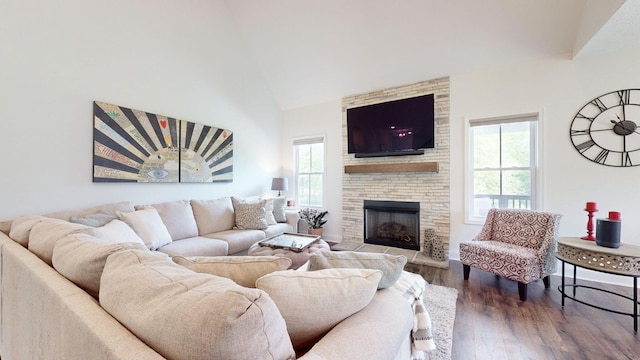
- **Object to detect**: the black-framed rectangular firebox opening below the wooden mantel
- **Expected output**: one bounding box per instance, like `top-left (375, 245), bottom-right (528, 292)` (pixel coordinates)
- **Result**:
top-left (363, 200), bottom-right (420, 250)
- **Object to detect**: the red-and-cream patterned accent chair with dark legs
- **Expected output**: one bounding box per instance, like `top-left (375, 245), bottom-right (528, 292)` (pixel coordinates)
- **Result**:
top-left (460, 209), bottom-right (561, 301)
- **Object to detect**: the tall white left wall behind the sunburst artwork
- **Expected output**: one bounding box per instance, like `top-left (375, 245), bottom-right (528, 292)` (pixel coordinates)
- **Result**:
top-left (0, 0), bottom-right (280, 220)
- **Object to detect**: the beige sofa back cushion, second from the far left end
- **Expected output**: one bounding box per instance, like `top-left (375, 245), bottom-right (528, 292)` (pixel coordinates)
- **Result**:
top-left (28, 219), bottom-right (91, 266)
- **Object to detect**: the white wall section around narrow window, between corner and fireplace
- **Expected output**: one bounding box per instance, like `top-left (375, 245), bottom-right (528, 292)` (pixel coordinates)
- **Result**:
top-left (281, 99), bottom-right (343, 240)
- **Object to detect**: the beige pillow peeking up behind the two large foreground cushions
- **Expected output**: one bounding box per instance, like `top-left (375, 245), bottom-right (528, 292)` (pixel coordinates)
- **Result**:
top-left (173, 256), bottom-right (291, 288)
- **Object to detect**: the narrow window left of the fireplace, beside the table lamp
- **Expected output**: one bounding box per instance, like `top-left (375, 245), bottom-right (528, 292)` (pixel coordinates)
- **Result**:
top-left (293, 136), bottom-right (324, 207)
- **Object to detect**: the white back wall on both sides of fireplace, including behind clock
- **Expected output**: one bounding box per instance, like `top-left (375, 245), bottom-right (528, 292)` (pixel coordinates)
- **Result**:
top-left (282, 51), bottom-right (640, 285)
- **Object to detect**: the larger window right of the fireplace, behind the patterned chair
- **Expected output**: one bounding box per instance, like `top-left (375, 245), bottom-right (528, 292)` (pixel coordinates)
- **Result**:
top-left (467, 114), bottom-right (539, 223)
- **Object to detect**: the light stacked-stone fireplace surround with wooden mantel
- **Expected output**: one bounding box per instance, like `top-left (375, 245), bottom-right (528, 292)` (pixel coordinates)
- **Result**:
top-left (342, 77), bottom-right (450, 260)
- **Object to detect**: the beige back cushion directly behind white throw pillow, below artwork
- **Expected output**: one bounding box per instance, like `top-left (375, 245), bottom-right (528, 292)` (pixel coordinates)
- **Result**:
top-left (135, 200), bottom-right (198, 240)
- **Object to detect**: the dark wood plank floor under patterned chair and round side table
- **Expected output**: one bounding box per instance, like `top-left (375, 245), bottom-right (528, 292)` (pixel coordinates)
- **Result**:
top-left (405, 260), bottom-right (640, 360)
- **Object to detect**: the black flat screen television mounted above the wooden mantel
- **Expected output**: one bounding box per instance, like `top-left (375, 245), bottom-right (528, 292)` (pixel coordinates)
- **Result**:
top-left (347, 94), bottom-right (434, 157)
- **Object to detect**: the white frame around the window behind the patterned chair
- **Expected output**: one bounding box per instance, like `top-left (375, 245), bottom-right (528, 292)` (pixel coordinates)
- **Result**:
top-left (464, 111), bottom-right (542, 225)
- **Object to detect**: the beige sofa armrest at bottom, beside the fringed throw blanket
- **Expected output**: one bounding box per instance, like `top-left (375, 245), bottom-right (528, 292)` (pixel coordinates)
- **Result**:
top-left (298, 289), bottom-right (413, 360)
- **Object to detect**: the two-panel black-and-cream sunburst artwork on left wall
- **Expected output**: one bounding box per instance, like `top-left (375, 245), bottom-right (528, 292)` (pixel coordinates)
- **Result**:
top-left (93, 101), bottom-right (233, 183)
